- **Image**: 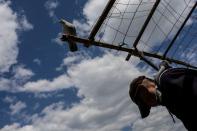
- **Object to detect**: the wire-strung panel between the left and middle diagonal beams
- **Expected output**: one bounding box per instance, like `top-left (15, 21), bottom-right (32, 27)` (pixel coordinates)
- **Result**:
top-left (95, 0), bottom-right (159, 48)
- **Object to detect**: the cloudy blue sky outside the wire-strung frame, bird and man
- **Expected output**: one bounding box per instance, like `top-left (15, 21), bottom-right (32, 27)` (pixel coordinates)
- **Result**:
top-left (0, 0), bottom-right (195, 131)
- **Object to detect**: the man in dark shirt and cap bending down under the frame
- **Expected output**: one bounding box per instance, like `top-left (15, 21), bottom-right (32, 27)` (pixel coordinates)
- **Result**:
top-left (129, 63), bottom-right (197, 131)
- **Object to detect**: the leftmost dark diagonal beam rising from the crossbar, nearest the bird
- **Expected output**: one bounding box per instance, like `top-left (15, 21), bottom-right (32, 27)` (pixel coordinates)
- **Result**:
top-left (87, 0), bottom-right (116, 40)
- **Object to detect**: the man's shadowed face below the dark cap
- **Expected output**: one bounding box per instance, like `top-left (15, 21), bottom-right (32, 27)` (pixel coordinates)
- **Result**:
top-left (138, 79), bottom-right (157, 106)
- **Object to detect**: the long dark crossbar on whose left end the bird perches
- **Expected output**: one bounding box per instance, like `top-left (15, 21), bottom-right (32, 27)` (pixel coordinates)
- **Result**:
top-left (61, 35), bottom-right (197, 69)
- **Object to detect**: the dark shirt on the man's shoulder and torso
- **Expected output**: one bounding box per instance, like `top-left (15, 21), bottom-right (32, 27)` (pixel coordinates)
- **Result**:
top-left (157, 68), bottom-right (197, 131)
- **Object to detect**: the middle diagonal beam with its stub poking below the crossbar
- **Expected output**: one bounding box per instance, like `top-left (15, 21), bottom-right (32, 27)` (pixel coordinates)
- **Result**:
top-left (126, 0), bottom-right (161, 61)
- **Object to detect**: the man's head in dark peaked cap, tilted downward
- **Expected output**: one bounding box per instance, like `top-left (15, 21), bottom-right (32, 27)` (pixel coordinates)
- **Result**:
top-left (129, 76), bottom-right (158, 118)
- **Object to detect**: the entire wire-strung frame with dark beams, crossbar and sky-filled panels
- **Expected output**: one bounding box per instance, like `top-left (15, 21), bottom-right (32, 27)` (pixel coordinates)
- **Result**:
top-left (61, 0), bottom-right (197, 70)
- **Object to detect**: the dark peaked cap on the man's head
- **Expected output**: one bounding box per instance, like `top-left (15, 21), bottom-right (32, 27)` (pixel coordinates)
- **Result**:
top-left (129, 76), bottom-right (151, 118)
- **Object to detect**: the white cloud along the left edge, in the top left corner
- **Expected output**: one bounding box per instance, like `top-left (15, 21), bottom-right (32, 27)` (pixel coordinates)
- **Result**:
top-left (0, 0), bottom-right (33, 73)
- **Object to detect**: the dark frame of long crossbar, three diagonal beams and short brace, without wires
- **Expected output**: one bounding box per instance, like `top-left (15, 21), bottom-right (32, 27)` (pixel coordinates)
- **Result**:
top-left (61, 0), bottom-right (197, 70)
